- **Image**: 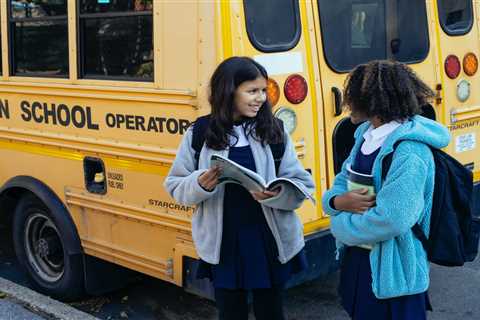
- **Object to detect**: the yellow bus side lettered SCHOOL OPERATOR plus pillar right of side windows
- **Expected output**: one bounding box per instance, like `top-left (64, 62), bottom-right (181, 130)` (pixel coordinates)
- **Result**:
top-left (0, 3), bottom-right (216, 285)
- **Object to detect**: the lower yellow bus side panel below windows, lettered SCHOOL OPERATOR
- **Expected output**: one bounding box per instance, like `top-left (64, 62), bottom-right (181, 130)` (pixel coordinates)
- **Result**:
top-left (0, 89), bottom-right (201, 281)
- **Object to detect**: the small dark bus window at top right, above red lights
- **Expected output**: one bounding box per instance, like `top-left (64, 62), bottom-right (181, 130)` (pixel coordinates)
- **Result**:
top-left (437, 0), bottom-right (473, 36)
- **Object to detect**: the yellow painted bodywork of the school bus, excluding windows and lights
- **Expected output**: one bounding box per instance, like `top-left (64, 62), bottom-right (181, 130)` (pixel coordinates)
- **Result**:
top-left (0, 0), bottom-right (480, 298)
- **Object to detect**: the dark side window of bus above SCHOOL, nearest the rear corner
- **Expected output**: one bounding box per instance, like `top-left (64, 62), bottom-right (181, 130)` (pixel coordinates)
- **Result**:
top-left (79, 0), bottom-right (153, 81)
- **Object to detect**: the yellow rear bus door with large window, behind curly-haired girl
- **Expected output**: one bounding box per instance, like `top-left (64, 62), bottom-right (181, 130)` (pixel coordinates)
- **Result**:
top-left (313, 0), bottom-right (437, 181)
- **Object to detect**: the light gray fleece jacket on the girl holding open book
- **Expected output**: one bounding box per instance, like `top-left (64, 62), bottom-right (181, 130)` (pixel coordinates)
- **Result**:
top-left (164, 128), bottom-right (314, 264)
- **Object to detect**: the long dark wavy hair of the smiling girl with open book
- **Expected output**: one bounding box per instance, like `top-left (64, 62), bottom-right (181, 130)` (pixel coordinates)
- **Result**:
top-left (205, 57), bottom-right (283, 150)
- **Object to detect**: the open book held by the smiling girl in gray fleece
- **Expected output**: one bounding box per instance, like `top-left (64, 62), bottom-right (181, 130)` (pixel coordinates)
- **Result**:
top-left (210, 154), bottom-right (315, 204)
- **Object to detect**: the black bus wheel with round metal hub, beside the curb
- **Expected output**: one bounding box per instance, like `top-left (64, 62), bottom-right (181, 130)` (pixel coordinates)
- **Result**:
top-left (13, 195), bottom-right (84, 300)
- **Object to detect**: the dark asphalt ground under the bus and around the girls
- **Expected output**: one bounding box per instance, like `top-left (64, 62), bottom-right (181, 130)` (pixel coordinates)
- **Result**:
top-left (0, 220), bottom-right (480, 320)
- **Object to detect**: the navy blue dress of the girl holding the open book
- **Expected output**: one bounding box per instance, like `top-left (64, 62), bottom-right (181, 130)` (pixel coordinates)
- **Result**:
top-left (197, 145), bottom-right (308, 290)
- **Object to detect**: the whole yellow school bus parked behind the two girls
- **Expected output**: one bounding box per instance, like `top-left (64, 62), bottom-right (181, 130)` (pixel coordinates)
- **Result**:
top-left (0, 0), bottom-right (480, 299)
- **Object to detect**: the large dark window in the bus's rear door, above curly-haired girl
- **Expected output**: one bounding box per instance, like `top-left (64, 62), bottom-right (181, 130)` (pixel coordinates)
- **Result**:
top-left (318, 0), bottom-right (429, 72)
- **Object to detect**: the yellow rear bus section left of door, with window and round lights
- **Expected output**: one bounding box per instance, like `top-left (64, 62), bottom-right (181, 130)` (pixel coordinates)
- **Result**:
top-left (239, 0), bottom-right (328, 234)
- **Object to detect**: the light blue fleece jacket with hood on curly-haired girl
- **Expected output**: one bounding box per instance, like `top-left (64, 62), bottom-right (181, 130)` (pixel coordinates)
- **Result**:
top-left (322, 116), bottom-right (450, 299)
